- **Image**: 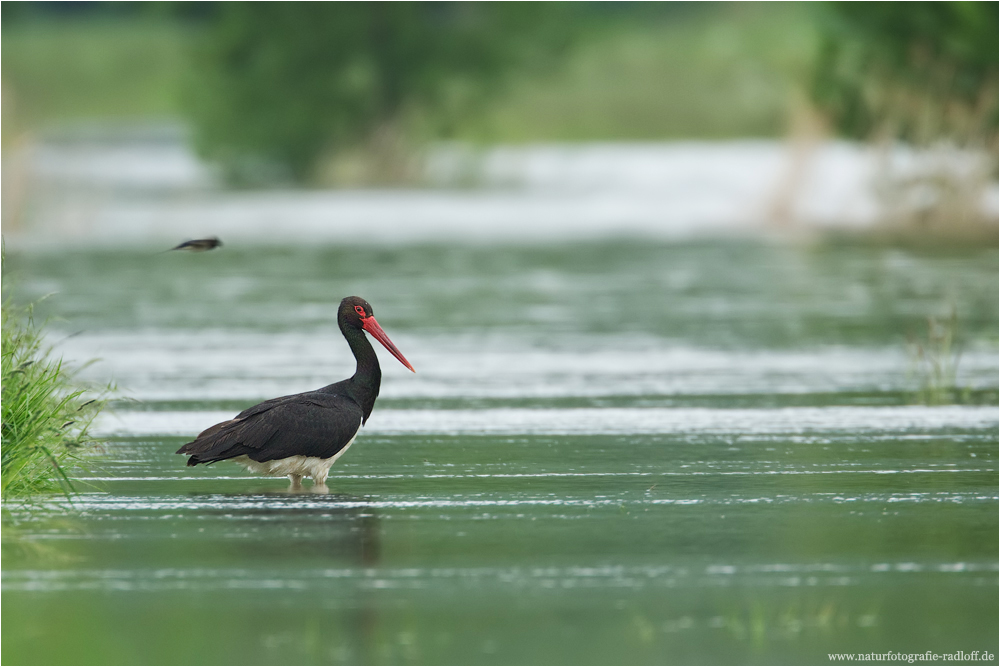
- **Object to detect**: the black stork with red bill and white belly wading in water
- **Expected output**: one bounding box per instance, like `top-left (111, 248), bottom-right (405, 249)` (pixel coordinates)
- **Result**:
top-left (177, 296), bottom-right (416, 487)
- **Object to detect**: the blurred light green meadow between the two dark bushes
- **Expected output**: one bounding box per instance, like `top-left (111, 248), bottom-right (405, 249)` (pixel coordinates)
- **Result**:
top-left (457, 2), bottom-right (817, 144)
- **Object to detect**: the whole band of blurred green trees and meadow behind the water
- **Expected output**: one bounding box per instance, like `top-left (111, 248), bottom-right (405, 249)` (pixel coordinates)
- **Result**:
top-left (2, 2), bottom-right (998, 184)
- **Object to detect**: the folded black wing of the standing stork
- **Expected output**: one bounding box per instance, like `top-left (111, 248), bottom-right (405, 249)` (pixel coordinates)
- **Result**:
top-left (177, 392), bottom-right (364, 466)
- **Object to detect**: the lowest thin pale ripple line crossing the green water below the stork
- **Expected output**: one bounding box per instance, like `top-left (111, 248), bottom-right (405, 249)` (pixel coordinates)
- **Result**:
top-left (2, 561), bottom-right (998, 592)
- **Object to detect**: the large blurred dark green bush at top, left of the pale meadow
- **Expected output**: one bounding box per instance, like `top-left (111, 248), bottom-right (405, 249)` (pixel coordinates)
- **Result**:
top-left (188, 2), bottom-right (573, 181)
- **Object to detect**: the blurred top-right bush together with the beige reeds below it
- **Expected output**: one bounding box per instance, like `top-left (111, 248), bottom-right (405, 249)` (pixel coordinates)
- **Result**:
top-left (810, 2), bottom-right (1000, 244)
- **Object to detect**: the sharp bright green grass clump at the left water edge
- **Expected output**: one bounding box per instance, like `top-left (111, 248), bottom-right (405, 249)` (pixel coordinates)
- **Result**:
top-left (0, 299), bottom-right (104, 506)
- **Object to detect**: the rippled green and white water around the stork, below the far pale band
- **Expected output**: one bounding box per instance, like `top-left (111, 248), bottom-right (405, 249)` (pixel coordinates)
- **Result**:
top-left (3, 239), bottom-right (998, 664)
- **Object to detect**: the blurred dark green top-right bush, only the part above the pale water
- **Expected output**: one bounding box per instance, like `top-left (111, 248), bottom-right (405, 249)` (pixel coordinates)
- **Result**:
top-left (812, 2), bottom-right (998, 146)
